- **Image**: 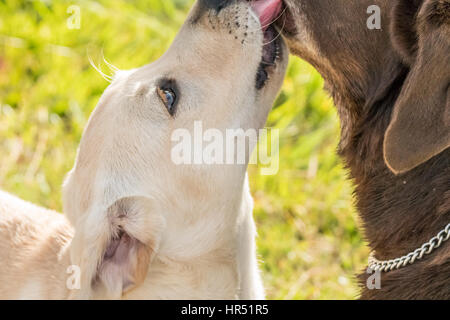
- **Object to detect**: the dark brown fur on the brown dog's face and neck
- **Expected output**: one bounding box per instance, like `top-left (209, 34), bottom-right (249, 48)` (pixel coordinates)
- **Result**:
top-left (285, 0), bottom-right (450, 299)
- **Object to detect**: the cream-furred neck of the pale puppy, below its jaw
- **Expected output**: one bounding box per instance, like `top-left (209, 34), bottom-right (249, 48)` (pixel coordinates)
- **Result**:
top-left (124, 174), bottom-right (252, 299)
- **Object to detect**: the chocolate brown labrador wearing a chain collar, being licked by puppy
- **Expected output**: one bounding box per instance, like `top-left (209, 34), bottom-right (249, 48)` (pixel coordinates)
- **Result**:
top-left (277, 0), bottom-right (450, 299)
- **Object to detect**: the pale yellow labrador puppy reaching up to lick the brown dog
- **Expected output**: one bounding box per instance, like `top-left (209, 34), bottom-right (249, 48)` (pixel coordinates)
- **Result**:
top-left (0, 0), bottom-right (288, 299)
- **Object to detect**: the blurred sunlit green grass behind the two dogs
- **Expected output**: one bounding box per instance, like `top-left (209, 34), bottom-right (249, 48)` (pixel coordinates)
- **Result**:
top-left (0, 0), bottom-right (367, 299)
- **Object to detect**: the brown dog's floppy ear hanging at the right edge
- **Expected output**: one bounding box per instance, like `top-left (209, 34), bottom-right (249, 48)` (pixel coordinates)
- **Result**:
top-left (384, 0), bottom-right (450, 174)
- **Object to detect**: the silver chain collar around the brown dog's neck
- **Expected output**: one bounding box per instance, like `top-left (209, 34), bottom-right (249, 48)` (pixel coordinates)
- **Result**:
top-left (369, 223), bottom-right (450, 272)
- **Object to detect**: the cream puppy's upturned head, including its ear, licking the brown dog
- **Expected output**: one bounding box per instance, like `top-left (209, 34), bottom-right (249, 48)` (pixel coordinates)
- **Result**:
top-left (64, 0), bottom-right (287, 298)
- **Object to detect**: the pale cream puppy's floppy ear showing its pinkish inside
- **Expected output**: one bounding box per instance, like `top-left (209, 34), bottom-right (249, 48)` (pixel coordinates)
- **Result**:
top-left (67, 197), bottom-right (164, 299)
